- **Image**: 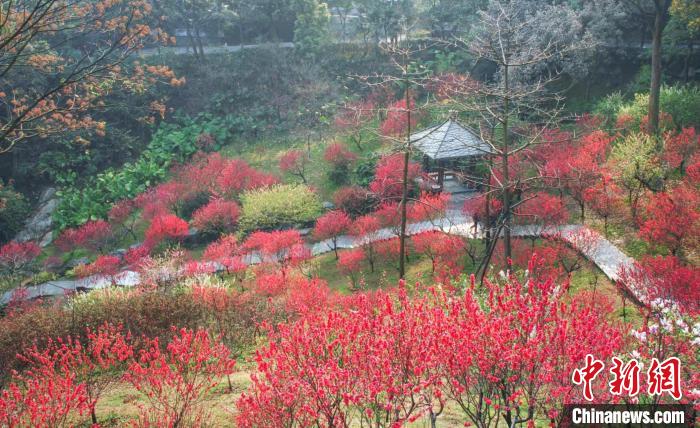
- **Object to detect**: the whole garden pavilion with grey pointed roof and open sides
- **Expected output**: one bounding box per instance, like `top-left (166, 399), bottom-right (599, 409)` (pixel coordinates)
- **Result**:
top-left (410, 118), bottom-right (492, 191)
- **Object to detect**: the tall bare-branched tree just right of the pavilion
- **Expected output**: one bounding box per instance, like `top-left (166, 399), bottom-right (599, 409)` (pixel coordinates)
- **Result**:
top-left (442, 0), bottom-right (589, 278)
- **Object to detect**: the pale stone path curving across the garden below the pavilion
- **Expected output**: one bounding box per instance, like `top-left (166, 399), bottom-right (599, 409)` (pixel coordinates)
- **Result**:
top-left (0, 211), bottom-right (644, 305)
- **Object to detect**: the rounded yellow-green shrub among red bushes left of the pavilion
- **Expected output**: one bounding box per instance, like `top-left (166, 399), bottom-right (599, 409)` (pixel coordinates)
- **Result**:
top-left (238, 185), bottom-right (322, 233)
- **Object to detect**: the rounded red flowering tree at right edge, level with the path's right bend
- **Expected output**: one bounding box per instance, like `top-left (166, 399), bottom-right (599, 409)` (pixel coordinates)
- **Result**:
top-left (639, 184), bottom-right (700, 256)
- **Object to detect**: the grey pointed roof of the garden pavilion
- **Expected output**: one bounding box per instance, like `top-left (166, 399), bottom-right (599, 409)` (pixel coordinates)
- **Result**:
top-left (411, 119), bottom-right (491, 160)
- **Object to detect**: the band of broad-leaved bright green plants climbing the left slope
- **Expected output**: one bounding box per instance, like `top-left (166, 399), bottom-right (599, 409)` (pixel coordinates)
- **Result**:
top-left (53, 116), bottom-right (235, 230)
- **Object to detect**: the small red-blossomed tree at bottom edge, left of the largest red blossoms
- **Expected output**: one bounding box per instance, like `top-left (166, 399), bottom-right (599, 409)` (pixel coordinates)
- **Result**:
top-left (124, 329), bottom-right (236, 426)
